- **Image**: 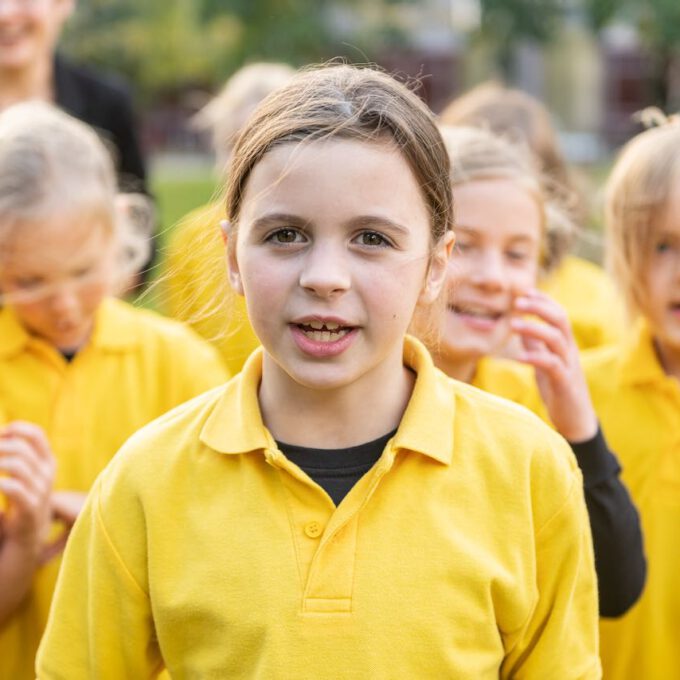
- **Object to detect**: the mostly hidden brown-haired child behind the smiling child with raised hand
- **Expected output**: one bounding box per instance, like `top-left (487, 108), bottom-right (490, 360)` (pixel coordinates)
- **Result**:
top-left (440, 83), bottom-right (623, 349)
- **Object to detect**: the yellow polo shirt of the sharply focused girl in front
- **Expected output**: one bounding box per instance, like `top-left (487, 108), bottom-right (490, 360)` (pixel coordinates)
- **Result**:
top-left (38, 339), bottom-right (600, 680)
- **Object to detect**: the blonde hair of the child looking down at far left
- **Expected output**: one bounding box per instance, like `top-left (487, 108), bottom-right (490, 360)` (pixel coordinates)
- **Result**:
top-left (0, 102), bottom-right (153, 300)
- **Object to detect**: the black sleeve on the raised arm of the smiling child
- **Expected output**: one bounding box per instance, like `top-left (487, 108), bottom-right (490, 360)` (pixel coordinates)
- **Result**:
top-left (570, 429), bottom-right (647, 618)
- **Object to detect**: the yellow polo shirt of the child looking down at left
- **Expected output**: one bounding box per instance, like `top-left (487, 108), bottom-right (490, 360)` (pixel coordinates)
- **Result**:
top-left (0, 299), bottom-right (227, 680)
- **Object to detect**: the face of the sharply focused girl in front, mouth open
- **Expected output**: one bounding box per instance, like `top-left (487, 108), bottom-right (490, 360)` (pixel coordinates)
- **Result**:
top-left (230, 140), bottom-right (447, 389)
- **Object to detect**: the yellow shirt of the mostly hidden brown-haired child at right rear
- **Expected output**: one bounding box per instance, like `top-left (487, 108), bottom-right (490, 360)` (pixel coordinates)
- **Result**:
top-left (539, 256), bottom-right (625, 350)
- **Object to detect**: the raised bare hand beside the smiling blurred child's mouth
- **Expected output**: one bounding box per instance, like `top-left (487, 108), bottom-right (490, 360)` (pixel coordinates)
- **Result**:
top-left (510, 290), bottom-right (598, 442)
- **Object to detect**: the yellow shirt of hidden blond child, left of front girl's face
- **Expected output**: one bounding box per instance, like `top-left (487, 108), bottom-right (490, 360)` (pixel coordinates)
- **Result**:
top-left (162, 204), bottom-right (260, 375)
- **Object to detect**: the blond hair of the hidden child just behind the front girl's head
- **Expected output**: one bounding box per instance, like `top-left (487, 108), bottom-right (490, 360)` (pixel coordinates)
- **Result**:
top-left (192, 62), bottom-right (295, 171)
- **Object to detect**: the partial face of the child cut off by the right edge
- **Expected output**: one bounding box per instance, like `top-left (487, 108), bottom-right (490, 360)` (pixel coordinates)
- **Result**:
top-left (644, 192), bottom-right (680, 364)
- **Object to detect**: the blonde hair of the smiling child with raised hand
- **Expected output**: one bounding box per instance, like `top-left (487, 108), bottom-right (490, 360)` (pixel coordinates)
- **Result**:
top-left (440, 125), bottom-right (573, 273)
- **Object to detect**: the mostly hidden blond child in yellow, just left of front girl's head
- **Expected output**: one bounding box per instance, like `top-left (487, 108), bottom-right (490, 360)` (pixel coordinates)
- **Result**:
top-left (163, 62), bottom-right (294, 373)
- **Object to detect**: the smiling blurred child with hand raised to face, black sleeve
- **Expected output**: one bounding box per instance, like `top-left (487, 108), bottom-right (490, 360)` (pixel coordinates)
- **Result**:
top-left (420, 127), bottom-right (645, 617)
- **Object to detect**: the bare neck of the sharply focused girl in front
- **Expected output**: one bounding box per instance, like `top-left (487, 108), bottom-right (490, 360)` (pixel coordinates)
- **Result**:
top-left (258, 352), bottom-right (415, 449)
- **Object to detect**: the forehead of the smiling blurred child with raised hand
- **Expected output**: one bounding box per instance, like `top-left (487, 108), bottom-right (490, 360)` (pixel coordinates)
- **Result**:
top-left (453, 178), bottom-right (542, 239)
